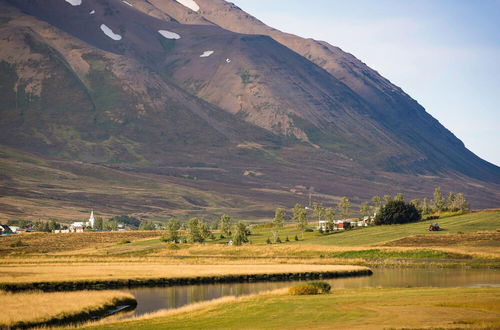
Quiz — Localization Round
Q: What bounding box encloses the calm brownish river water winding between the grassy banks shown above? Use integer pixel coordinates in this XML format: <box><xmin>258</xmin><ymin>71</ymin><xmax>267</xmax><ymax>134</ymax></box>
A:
<box><xmin>116</xmin><ymin>269</ymin><xmax>500</xmax><ymax>318</ymax></box>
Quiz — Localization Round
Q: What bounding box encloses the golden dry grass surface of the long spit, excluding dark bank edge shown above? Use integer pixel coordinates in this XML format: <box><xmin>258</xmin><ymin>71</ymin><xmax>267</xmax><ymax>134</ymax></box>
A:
<box><xmin>0</xmin><ymin>262</ymin><xmax>366</xmax><ymax>283</ymax></box>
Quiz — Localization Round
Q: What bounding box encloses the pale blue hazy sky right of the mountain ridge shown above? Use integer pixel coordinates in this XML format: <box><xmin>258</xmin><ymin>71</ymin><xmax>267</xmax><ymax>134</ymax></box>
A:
<box><xmin>229</xmin><ymin>0</ymin><xmax>500</xmax><ymax>165</ymax></box>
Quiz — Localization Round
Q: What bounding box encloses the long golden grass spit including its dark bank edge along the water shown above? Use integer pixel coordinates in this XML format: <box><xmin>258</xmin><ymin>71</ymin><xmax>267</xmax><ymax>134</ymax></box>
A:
<box><xmin>0</xmin><ymin>263</ymin><xmax>371</xmax><ymax>291</ymax></box>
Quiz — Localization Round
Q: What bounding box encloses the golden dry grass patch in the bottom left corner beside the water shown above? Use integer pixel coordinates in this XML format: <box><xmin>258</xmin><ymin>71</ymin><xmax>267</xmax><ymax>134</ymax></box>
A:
<box><xmin>0</xmin><ymin>291</ymin><xmax>134</xmax><ymax>328</ymax></box>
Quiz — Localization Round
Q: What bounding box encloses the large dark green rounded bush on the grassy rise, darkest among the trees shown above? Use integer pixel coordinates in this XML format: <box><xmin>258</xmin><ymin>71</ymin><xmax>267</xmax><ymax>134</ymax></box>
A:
<box><xmin>375</xmin><ymin>200</ymin><xmax>422</xmax><ymax>225</ymax></box>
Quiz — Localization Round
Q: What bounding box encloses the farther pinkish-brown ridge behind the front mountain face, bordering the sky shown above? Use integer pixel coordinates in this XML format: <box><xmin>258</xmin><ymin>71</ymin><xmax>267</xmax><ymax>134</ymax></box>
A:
<box><xmin>130</xmin><ymin>0</ymin><xmax>500</xmax><ymax>182</ymax></box>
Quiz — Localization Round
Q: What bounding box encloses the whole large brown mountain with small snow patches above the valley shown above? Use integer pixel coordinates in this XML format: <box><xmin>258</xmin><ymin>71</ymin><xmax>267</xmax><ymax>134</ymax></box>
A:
<box><xmin>0</xmin><ymin>0</ymin><xmax>500</xmax><ymax>222</ymax></box>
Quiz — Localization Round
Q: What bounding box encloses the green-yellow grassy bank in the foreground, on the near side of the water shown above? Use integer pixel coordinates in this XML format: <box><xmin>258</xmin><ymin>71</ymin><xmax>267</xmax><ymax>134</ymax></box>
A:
<box><xmin>90</xmin><ymin>288</ymin><xmax>500</xmax><ymax>329</ymax></box>
